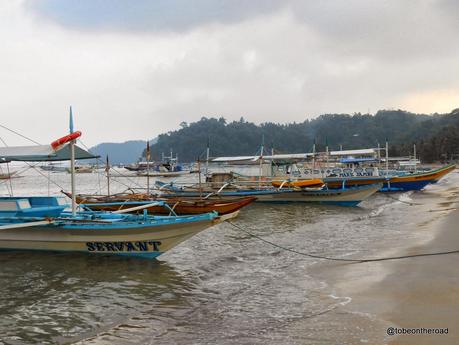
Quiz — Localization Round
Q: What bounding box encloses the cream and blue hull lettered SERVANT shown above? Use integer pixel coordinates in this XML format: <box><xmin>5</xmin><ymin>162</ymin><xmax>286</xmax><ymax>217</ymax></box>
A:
<box><xmin>0</xmin><ymin>214</ymin><xmax>221</xmax><ymax>258</ymax></box>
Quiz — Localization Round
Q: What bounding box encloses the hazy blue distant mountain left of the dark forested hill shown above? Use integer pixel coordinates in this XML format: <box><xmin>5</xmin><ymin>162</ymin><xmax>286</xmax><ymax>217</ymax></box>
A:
<box><xmin>90</xmin><ymin>138</ymin><xmax>157</xmax><ymax>164</ymax></box>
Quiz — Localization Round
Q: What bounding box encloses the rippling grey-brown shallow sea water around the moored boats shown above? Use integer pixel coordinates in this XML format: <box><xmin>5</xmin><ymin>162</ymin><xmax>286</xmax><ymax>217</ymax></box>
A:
<box><xmin>0</xmin><ymin>166</ymin><xmax>459</xmax><ymax>344</ymax></box>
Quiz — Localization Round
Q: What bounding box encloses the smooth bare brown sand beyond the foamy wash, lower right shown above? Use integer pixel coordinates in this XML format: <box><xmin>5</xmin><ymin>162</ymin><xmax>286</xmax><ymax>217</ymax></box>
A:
<box><xmin>382</xmin><ymin>206</ymin><xmax>459</xmax><ymax>344</ymax></box>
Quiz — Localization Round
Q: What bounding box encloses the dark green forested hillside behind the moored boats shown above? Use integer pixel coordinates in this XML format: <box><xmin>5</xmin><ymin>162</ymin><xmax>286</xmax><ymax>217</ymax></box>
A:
<box><xmin>148</xmin><ymin>109</ymin><xmax>459</xmax><ymax>161</ymax></box>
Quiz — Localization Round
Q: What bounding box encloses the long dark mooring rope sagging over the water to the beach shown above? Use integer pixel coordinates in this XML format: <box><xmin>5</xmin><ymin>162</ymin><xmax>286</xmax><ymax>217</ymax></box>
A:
<box><xmin>226</xmin><ymin>220</ymin><xmax>459</xmax><ymax>263</ymax></box>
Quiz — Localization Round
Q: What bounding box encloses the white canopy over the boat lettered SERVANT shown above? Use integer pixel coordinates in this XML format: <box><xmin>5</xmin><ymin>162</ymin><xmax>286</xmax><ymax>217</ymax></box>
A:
<box><xmin>0</xmin><ymin>144</ymin><xmax>99</xmax><ymax>163</ymax></box>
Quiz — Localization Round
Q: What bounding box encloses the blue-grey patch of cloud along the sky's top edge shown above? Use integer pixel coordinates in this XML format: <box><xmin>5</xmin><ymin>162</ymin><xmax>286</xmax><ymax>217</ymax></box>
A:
<box><xmin>25</xmin><ymin>0</ymin><xmax>282</xmax><ymax>32</ymax></box>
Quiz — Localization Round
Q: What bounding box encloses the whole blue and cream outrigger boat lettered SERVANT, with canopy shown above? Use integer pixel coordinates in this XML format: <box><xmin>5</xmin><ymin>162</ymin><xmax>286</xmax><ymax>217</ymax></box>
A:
<box><xmin>0</xmin><ymin>114</ymin><xmax>233</xmax><ymax>258</ymax></box>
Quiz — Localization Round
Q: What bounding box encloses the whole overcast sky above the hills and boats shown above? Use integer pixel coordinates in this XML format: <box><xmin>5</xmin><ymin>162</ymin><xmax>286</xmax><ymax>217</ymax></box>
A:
<box><xmin>0</xmin><ymin>0</ymin><xmax>459</xmax><ymax>145</ymax></box>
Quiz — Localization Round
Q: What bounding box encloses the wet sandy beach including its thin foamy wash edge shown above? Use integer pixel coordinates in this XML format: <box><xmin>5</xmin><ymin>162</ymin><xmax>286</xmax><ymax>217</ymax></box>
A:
<box><xmin>314</xmin><ymin>176</ymin><xmax>459</xmax><ymax>345</ymax></box>
